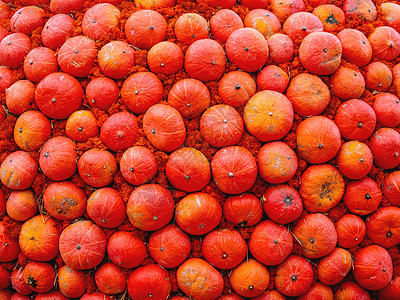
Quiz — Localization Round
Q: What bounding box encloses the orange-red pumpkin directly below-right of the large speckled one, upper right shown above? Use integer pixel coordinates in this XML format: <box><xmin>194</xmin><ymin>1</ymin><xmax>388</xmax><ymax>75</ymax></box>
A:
<box><xmin>330</xmin><ymin>66</ymin><xmax>365</xmax><ymax>100</ymax></box>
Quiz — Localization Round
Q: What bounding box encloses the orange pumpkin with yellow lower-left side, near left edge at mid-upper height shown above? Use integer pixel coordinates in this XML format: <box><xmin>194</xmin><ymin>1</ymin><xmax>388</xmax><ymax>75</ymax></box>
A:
<box><xmin>14</xmin><ymin>110</ymin><xmax>51</xmax><ymax>151</ymax></box>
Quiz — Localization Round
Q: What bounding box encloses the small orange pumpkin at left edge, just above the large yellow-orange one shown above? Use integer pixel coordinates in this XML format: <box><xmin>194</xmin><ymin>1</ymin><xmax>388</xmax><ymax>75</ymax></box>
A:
<box><xmin>6</xmin><ymin>190</ymin><xmax>38</xmax><ymax>222</ymax></box>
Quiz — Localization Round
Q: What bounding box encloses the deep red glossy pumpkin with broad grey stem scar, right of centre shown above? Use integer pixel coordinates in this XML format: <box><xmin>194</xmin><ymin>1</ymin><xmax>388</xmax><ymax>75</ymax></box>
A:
<box><xmin>261</xmin><ymin>185</ymin><xmax>303</xmax><ymax>224</ymax></box>
